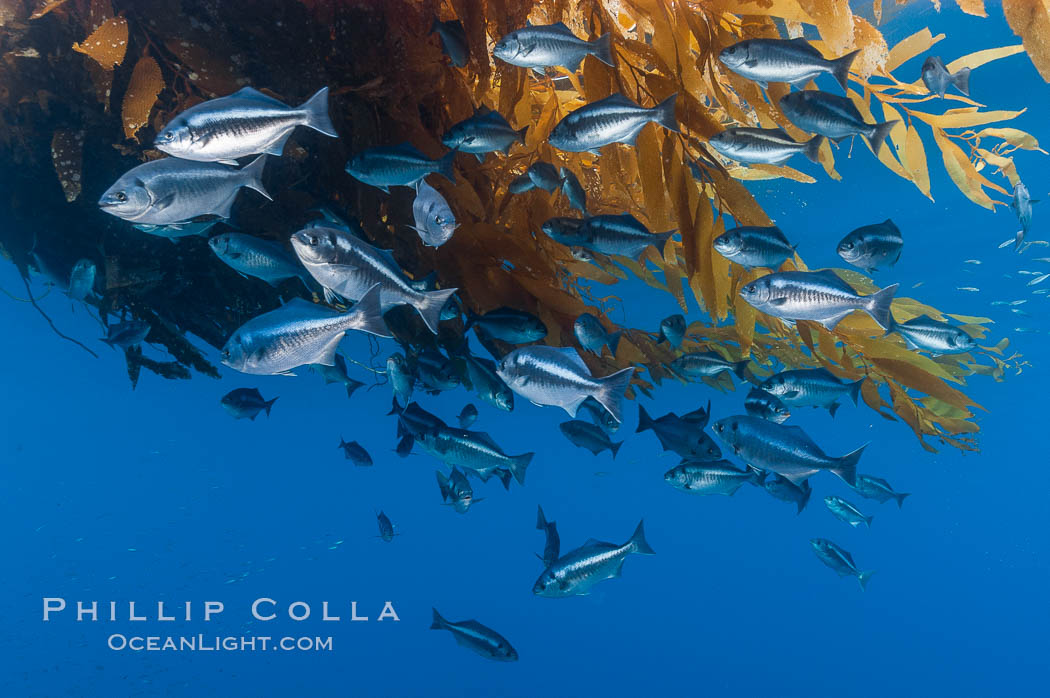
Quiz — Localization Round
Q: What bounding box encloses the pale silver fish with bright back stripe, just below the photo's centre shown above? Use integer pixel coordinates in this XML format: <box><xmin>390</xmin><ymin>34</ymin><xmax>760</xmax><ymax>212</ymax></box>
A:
<box><xmin>496</xmin><ymin>345</ymin><xmax>634</xmax><ymax>422</ymax></box>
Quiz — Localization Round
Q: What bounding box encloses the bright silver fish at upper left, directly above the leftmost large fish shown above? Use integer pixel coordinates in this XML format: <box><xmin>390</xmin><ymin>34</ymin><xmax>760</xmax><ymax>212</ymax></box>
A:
<box><xmin>153</xmin><ymin>87</ymin><xmax>331</xmax><ymax>165</ymax></box>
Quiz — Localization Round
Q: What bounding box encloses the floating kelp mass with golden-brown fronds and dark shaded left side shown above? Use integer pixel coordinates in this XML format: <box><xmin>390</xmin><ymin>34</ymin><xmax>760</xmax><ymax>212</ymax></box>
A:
<box><xmin>0</xmin><ymin>0</ymin><xmax>1048</xmax><ymax>449</ymax></box>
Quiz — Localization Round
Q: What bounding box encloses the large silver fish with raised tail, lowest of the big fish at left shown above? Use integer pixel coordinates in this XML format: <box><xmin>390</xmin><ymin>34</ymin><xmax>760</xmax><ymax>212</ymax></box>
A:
<box><xmin>222</xmin><ymin>284</ymin><xmax>390</xmax><ymax>376</ymax></box>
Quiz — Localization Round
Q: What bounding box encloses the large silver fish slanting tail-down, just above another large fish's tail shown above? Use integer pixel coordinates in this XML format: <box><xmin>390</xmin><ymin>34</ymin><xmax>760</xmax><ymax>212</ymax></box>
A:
<box><xmin>292</xmin><ymin>227</ymin><xmax>458</xmax><ymax>334</ymax></box>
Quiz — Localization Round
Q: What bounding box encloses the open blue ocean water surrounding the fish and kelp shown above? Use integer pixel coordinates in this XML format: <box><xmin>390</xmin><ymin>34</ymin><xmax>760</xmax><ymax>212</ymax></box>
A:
<box><xmin>0</xmin><ymin>3</ymin><xmax>1050</xmax><ymax>697</ymax></box>
